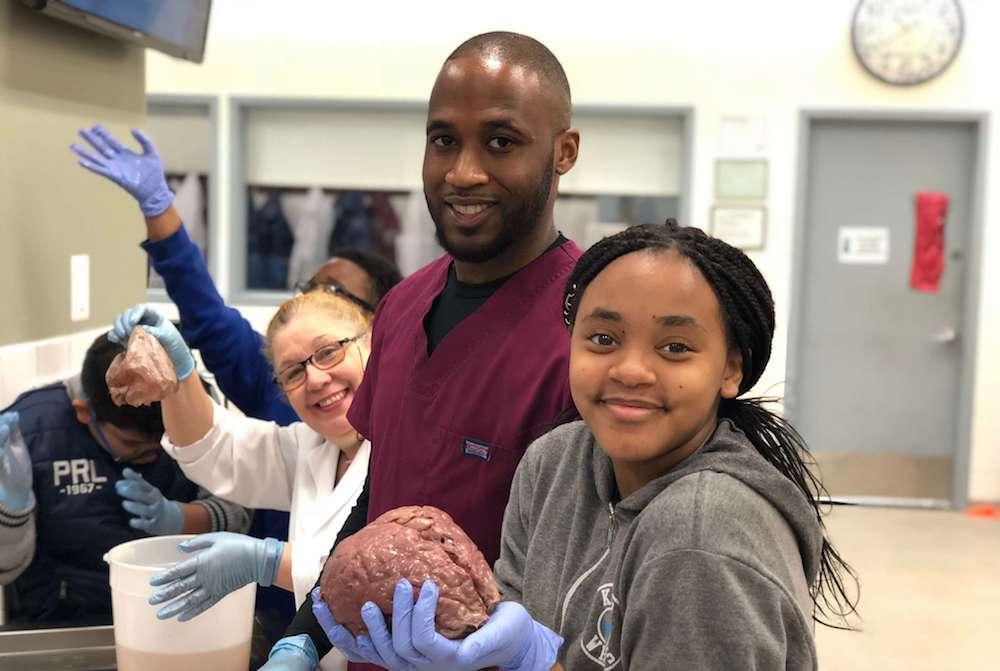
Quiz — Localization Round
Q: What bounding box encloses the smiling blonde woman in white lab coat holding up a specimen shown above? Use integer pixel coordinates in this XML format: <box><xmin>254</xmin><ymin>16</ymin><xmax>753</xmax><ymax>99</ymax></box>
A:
<box><xmin>111</xmin><ymin>291</ymin><xmax>371</xmax><ymax>670</ymax></box>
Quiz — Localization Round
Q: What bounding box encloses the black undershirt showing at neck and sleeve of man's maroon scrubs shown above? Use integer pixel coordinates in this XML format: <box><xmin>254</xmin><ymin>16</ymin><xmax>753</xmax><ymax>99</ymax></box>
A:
<box><xmin>285</xmin><ymin>233</ymin><xmax>566</xmax><ymax>659</ymax></box>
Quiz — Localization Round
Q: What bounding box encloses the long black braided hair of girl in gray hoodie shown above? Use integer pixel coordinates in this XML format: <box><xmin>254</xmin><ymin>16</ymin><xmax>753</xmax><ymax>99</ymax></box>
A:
<box><xmin>563</xmin><ymin>219</ymin><xmax>857</xmax><ymax>628</ymax></box>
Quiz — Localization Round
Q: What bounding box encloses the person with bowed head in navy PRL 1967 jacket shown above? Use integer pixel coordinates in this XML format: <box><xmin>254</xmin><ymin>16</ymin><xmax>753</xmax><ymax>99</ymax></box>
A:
<box><xmin>0</xmin><ymin>335</ymin><xmax>250</xmax><ymax>624</ymax></box>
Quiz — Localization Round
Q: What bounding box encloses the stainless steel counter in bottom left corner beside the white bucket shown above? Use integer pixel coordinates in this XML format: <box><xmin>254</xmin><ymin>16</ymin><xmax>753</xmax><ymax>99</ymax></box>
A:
<box><xmin>0</xmin><ymin>626</ymin><xmax>117</xmax><ymax>671</ymax></box>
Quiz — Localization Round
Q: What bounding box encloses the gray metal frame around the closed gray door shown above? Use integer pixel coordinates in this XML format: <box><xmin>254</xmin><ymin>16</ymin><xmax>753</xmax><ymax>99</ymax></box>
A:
<box><xmin>785</xmin><ymin>109</ymin><xmax>990</xmax><ymax>509</ymax></box>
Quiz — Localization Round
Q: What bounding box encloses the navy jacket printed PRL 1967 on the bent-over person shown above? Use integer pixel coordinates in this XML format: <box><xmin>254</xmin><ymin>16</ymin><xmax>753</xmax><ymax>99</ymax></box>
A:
<box><xmin>8</xmin><ymin>383</ymin><xmax>198</xmax><ymax>622</ymax></box>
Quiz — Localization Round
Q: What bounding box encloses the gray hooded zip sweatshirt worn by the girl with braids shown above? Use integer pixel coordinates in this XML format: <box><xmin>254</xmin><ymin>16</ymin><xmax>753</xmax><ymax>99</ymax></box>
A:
<box><xmin>495</xmin><ymin>420</ymin><xmax>823</xmax><ymax>671</ymax></box>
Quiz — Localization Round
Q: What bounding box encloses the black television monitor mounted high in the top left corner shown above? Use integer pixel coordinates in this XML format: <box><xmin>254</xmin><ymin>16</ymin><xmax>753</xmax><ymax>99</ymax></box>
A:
<box><xmin>22</xmin><ymin>0</ymin><xmax>212</xmax><ymax>63</ymax></box>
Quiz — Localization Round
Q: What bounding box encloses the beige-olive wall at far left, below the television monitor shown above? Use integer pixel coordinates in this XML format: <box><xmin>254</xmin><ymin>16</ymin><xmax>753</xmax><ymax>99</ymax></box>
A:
<box><xmin>0</xmin><ymin>1</ymin><xmax>146</xmax><ymax>345</ymax></box>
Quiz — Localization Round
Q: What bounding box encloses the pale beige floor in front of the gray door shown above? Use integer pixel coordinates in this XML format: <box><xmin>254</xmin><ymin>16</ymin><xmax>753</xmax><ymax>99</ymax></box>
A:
<box><xmin>816</xmin><ymin>506</ymin><xmax>1000</xmax><ymax>671</ymax></box>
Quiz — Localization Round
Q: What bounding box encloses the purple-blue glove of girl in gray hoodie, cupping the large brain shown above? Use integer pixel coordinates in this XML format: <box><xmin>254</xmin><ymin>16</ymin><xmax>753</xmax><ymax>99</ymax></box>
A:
<box><xmin>361</xmin><ymin>580</ymin><xmax>563</xmax><ymax>671</ymax></box>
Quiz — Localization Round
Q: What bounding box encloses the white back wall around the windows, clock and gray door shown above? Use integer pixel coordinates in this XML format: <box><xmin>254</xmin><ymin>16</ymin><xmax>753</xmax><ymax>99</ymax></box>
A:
<box><xmin>147</xmin><ymin>0</ymin><xmax>1000</xmax><ymax>499</ymax></box>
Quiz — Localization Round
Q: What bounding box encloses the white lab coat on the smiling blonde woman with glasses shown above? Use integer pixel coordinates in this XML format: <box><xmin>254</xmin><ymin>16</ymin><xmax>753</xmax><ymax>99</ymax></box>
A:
<box><xmin>163</xmin><ymin>404</ymin><xmax>371</xmax><ymax>671</ymax></box>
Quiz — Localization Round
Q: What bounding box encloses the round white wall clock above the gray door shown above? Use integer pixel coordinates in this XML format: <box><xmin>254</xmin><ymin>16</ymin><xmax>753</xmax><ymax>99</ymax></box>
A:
<box><xmin>851</xmin><ymin>0</ymin><xmax>963</xmax><ymax>86</ymax></box>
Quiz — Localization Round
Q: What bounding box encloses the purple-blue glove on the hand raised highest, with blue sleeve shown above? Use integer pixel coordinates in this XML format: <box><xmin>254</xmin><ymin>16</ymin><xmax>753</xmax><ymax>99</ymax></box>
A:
<box><xmin>69</xmin><ymin>124</ymin><xmax>174</xmax><ymax>217</ymax></box>
